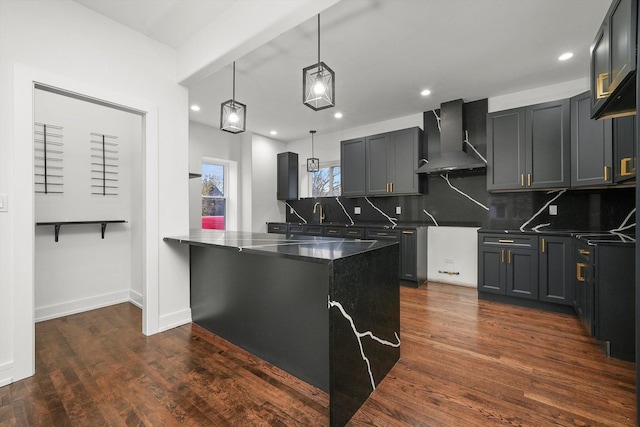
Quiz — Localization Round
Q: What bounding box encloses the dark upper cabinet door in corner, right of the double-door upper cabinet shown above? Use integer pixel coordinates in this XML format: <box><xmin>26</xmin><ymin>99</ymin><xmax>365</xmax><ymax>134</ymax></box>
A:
<box><xmin>571</xmin><ymin>92</ymin><xmax>613</xmax><ymax>187</ymax></box>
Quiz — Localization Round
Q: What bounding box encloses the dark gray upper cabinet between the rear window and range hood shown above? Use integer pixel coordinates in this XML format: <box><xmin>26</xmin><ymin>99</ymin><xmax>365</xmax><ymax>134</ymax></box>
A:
<box><xmin>340</xmin><ymin>127</ymin><xmax>427</xmax><ymax>196</ymax></box>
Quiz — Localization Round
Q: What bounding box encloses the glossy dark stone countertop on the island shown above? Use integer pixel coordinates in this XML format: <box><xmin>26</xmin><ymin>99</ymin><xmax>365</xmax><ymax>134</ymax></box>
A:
<box><xmin>164</xmin><ymin>229</ymin><xmax>398</xmax><ymax>263</ymax></box>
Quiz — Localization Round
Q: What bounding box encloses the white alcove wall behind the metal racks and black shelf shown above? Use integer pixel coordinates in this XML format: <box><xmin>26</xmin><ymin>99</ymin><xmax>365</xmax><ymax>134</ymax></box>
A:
<box><xmin>34</xmin><ymin>90</ymin><xmax>143</xmax><ymax>322</ymax></box>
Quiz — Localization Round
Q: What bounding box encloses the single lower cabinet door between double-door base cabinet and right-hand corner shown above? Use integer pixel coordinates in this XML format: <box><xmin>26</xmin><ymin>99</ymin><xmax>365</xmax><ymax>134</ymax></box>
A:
<box><xmin>538</xmin><ymin>236</ymin><xmax>574</xmax><ymax>305</ymax></box>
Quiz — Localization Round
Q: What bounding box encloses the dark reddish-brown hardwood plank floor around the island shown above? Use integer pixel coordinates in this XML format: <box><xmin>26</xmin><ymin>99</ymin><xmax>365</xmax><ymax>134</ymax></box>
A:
<box><xmin>0</xmin><ymin>283</ymin><xmax>636</xmax><ymax>426</ymax></box>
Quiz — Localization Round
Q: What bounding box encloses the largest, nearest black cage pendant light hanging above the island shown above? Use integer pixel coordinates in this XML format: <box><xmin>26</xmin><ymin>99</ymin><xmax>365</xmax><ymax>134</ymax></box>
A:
<box><xmin>302</xmin><ymin>14</ymin><xmax>336</xmax><ymax>111</ymax></box>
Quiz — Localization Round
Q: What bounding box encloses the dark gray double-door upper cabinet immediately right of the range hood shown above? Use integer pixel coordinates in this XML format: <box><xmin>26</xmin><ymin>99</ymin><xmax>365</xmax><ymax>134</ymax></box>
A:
<box><xmin>487</xmin><ymin>99</ymin><xmax>571</xmax><ymax>191</ymax></box>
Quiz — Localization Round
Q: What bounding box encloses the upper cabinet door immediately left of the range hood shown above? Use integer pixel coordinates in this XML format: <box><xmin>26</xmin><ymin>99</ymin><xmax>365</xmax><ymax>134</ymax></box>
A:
<box><xmin>389</xmin><ymin>128</ymin><xmax>421</xmax><ymax>194</ymax></box>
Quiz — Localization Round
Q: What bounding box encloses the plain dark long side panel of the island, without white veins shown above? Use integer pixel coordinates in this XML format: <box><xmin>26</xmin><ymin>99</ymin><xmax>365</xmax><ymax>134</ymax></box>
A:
<box><xmin>190</xmin><ymin>246</ymin><xmax>329</xmax><ymax>392</ymax></box>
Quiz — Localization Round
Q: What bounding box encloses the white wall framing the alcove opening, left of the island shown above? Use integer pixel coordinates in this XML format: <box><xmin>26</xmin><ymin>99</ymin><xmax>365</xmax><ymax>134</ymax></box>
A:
<box><xmin>0</xmin><ymin>0</ymin><xmax>190</xmax><ymax>385</ymax></box>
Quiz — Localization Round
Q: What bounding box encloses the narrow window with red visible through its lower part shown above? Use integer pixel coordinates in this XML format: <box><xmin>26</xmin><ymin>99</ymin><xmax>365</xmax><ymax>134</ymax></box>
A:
<box><xmin>202</xmin><ymin>163</ymin><xmax>227</xmax><ymax>230</ymax></box>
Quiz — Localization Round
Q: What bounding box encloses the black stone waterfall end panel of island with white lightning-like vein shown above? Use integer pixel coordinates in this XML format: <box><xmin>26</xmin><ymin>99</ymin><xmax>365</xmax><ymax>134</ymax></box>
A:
<box><xmin>329</xmin><ymin>245</ymin><xmax>400</xmax><ymax>426</ymax></box>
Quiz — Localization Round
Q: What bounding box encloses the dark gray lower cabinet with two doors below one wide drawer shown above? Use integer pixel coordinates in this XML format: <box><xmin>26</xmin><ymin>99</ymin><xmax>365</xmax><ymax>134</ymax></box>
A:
<box><xmin>478</xmin><ymin>232</ymin><xmax>538</xmax><ymax>300</ymax></box>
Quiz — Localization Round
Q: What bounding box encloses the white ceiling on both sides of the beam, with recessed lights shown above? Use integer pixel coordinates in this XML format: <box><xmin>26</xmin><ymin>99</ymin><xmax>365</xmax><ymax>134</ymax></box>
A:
<box><xmin>76</xmin><ymin>0</ymin><xmax>610</xmax><ymax>141</ymax></box>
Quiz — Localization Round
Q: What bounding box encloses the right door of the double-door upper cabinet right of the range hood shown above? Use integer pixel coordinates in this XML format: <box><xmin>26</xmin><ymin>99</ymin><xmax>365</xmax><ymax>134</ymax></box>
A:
<box><xmin>525</xmin><ymin>99</ymin><xmax>571</xmax><ymax>188</ymax></box>
